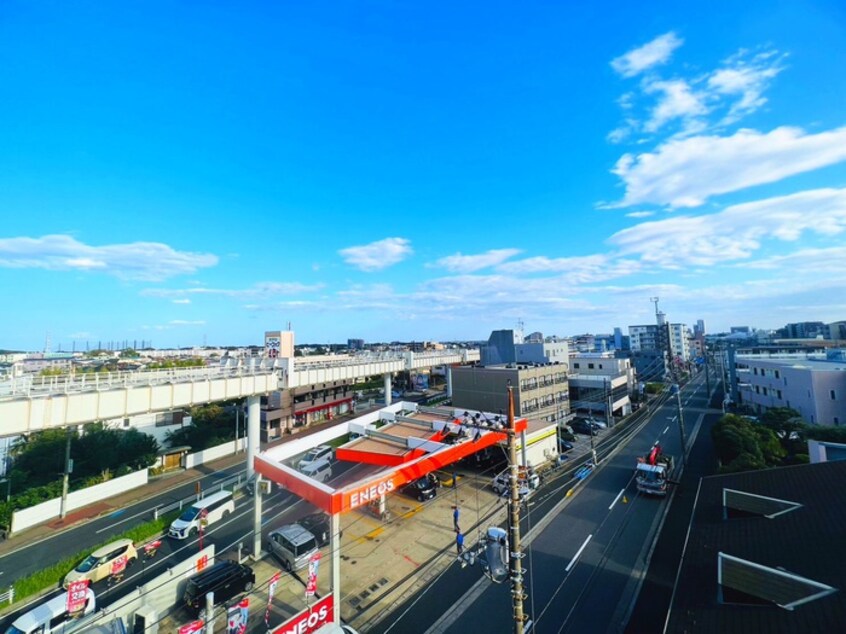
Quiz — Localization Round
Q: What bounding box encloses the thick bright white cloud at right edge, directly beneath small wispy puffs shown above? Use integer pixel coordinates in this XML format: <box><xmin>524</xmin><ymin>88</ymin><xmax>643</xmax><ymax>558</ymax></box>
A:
<box><xmin>609</xmin><ymin>127</ymin><xmax>846</xmax><ymax>207</ymax></box>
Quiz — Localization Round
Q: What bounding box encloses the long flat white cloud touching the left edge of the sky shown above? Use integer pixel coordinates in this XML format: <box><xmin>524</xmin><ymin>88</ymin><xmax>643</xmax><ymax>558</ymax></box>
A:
<box><xmin>0</xmin><ymin>235</ymin><xmax>218</xmax><ymax>281</ymax></box>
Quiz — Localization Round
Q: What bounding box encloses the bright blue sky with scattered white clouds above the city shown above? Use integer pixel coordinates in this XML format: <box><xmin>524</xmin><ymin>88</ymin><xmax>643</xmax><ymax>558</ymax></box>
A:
<box><xmin>0</xmin><ymin>1</ymin><xmax>846</xmax><ymax>350</ymax></box>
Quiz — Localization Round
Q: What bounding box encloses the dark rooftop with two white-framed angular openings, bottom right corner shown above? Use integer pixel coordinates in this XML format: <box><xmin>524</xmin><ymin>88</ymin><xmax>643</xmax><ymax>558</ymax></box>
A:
<box><xmin>666</xmin><ymin>462</ymin><xmax>846</xmax><ymax>634</ymax></box>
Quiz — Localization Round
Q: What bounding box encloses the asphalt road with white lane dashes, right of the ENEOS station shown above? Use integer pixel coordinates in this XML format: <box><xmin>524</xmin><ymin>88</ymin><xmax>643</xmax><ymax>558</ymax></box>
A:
<box><xmin>372</xmin><ymin>370</ymin><xmax>716</xmax><ymax>634</ymax></box>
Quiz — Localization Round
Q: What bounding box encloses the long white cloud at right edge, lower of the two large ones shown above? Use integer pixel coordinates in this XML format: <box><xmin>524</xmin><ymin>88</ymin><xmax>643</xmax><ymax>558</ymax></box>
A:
<box><xmin>608</xmin><ymin>188</ymin><xmax>846</xmax><ymax>269</ymax></box>
